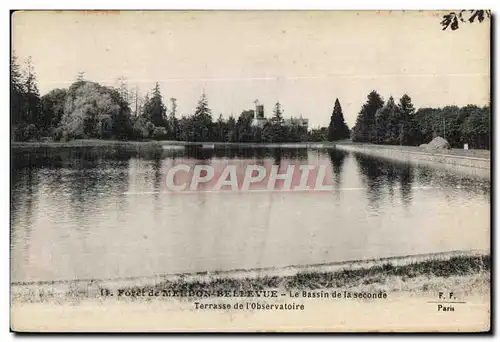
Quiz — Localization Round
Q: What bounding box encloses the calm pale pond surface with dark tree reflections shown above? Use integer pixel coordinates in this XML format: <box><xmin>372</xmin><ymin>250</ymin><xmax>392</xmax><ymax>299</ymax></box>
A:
<box><xmin>11</xmin><ymin>148</ymin><xmax>490</xmax><ymax>281</ymax></box>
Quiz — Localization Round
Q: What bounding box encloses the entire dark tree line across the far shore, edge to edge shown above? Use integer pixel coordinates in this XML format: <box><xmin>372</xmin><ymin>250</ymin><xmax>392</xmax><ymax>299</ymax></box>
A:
<box><xmin>11</xmin><ymin>56</ymin><xmax>490</xmax><ymax>148</ymax></box>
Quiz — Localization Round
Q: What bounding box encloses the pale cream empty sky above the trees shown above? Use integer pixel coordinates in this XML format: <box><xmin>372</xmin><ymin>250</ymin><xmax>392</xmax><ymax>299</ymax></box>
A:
<box><xmin>12</xmin><ymin>11</ymin><xmax>490</xmax><ymax>127</ymax></box>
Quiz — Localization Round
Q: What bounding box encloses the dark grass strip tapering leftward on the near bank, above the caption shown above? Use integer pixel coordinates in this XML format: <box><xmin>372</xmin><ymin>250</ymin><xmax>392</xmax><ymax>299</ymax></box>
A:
<box><xmin>102</xmin><ymin>255</ymin><xmax>490</xmax><ymax>293</ymax></box>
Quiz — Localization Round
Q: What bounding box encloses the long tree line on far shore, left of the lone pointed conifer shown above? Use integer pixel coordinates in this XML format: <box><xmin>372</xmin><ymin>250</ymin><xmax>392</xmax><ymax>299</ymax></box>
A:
<box><xmin>11</xmin><ymin>56</ymin><xmax>336</xmax><ymax>143</ymax></box>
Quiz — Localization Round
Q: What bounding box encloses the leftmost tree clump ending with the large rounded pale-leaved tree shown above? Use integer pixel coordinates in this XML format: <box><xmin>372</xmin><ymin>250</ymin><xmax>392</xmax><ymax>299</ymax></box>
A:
<box><xmin>10</xmin><ymin>56</ymin><xmax>132</xmax><ymax>141</ymax></box>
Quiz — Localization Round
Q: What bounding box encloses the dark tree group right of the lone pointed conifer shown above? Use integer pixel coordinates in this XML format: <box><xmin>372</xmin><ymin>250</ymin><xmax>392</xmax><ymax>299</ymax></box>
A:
<box><xmin>352</xmin><ymin>91</ymin><xmax>490</xmax><ymax>149</ymax></box>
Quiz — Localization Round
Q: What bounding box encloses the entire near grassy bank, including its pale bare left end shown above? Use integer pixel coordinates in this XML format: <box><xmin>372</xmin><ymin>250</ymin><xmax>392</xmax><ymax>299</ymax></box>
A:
<box><xmin>12</xmin><ymin>254</ymin><xmax>491</xmax><ymax>302</ymax></box>
